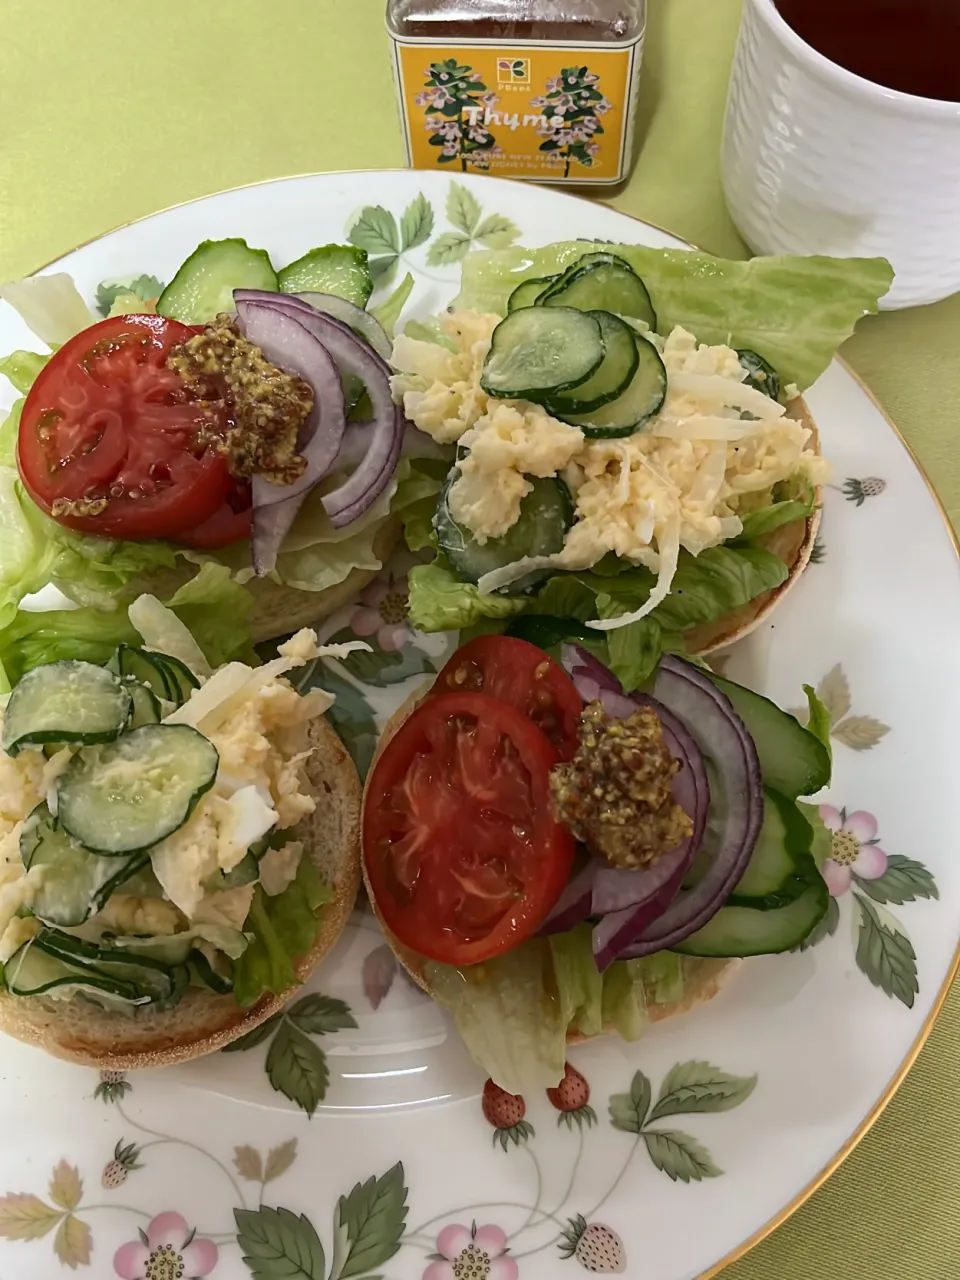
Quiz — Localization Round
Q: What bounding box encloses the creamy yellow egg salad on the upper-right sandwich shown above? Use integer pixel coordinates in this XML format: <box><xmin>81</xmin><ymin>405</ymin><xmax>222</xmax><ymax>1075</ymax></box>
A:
<box><xmin>393</xmin><ymin>311</ymin><xmax>829</xmax><ymax>626</ymax></box>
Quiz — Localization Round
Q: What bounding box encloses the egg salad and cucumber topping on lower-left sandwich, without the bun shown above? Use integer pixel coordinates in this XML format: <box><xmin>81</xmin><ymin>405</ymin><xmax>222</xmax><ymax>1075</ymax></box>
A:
<box><xmin>0</xmin><ymin>596</ymin><xmax>367</xmax><ymax>1007</ymax></box>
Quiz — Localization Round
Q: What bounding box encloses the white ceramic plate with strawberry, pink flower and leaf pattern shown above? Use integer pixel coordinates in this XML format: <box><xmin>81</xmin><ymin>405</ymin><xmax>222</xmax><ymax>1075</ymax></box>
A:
<box><xmin>0</xmin><ymin>173</ymin><xmax>960</xmax><ymax>1280</ymax></box>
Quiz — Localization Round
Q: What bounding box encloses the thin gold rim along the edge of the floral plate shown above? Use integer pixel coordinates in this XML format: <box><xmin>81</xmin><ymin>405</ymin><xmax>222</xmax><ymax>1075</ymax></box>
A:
<box><xmin>15</xmin><ymin>166</ymin><xmax>960</xmax><ymax>1280</ymax></box>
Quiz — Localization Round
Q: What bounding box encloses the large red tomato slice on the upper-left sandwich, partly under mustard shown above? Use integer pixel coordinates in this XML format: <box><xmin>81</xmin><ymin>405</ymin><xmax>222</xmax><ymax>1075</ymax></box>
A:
<box><xmin>17</xmin><ymin>315</ymin><xmax>248</xmax><ymax>545</ymax></box>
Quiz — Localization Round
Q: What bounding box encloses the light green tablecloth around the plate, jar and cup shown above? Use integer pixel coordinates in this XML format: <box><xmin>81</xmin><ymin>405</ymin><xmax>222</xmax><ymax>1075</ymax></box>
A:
<box><xmin>0</xmin><ymin>0</ymin><xmax>960</xmax><ymax>1280</ymax></box>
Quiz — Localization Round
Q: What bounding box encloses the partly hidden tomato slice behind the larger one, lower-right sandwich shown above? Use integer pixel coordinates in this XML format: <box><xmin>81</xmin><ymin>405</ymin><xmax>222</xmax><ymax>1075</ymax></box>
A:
<box><xmin>433</xmin><ymin>636</ymin><xmax>584</xmax><ymax>760</ymax></box>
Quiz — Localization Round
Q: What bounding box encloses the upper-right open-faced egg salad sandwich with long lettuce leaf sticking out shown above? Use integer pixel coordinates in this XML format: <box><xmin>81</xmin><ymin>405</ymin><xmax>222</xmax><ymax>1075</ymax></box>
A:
<box><xmin>393</xmin><ymin>242</ymin><xmax>890</xmax><ymax>689</ymax></box>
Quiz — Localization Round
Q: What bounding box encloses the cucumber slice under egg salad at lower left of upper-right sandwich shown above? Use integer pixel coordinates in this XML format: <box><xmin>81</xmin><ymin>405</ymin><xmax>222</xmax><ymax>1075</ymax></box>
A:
<box><xmin>434</xmin><ymin>467</ymin><xmax>573</xmax><ymax>595</ymax></box>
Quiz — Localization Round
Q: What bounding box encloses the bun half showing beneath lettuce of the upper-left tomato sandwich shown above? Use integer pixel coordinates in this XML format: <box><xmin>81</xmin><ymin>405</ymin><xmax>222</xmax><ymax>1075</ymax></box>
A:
<box><xmin>137</xmin><ymin>518</ymin><xmax>401</xmax><ymax>644</ymax></box>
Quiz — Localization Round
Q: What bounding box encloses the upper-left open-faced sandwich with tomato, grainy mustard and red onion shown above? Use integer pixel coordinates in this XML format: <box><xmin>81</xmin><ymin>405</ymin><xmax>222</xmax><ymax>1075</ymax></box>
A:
<box><xmin>0</xmin><ymin>239</ymin><xmax>436</xmax><ymax>648</ymax></box>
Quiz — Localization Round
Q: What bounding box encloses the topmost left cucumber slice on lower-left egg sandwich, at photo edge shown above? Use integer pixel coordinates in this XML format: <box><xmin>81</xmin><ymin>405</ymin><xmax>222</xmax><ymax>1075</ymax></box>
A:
<box><xmin>0</xmin><ymin>659</ymin><xmax>132</xmax><ymax>755</ymax></box>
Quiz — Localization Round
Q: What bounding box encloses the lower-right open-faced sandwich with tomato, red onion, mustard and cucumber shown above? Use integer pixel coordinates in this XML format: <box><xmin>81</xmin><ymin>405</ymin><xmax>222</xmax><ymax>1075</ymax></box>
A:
<box><xmin>364</xmin><ymin>636</ymin><xmax>831</xmax><ymax>1093</ymax></box>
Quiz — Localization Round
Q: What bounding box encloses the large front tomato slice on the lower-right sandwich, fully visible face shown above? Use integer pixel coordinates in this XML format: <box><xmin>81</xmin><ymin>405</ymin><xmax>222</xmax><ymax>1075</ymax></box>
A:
<box><xmin>364</xmin><ymin>692</ymin><xmax>575</xmax><ymax>965</ymax></box>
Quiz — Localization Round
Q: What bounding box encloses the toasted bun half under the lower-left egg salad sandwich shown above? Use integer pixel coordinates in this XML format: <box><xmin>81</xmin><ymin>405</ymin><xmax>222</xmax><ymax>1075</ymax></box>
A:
<box><xmin>0</xmin><ymin>717</ymin><xmax>360</xmax><ymax>1071</ymax></box>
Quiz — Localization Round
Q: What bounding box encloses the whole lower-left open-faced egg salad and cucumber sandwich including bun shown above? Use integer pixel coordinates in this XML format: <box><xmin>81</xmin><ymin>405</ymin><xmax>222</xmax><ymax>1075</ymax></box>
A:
<box><xmin>0</xmin><ymin>595</ymin><xmax>360</xmax><ymax>1069</ymax></box>
